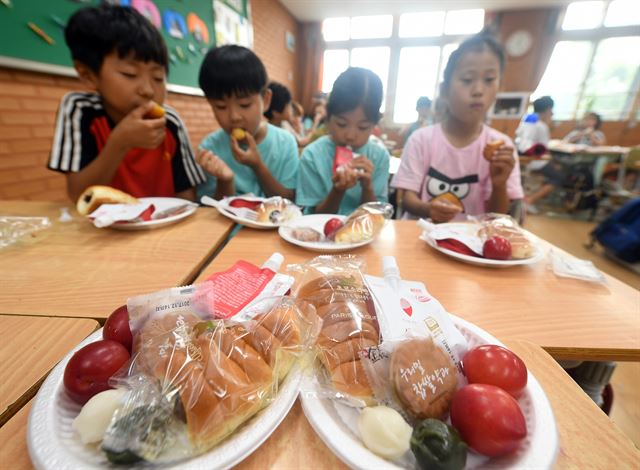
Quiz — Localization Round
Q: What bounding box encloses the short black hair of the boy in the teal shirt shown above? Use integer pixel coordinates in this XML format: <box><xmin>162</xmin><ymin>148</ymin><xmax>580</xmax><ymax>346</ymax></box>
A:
<box><xmin>199</xmin><ymin>45</ymin><xmax>267</xmax><ymax>100</ymax></box>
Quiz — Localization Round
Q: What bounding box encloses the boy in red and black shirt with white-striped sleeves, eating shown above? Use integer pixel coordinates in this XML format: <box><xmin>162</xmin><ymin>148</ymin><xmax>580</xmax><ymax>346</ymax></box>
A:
<box><xmin>49</xmin><ymin>6</ymin><xmax>205</xmax><ymax>201</ymax></box>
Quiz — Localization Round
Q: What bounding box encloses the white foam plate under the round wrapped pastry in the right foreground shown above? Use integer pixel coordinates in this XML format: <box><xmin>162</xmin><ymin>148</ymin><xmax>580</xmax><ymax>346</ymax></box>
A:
<box><xmin>300</xmin><ymin>315</ymin><xmax>560</xmax><ymax>470</ymax></box>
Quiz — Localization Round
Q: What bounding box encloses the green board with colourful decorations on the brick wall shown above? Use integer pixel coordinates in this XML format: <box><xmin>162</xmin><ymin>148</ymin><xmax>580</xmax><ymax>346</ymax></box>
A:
<box><xmin>0</xmin><ymin>0</ymin><xmax>249</xmax><ymax>92</ymax></box>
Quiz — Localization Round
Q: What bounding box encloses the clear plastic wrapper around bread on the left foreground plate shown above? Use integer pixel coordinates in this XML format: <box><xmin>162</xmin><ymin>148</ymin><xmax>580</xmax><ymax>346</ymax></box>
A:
<box><xmin>102</xmin><ymin>282</ymin><xmax>320</xmax><ymax>463</ymax></box>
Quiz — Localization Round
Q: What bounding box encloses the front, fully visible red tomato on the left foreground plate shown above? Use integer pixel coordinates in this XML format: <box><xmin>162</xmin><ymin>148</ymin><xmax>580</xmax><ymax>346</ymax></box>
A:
<box><xmin>64</xmin><ymin>339</ymin><xmax>129</xmax><ymax>405</ymax></box>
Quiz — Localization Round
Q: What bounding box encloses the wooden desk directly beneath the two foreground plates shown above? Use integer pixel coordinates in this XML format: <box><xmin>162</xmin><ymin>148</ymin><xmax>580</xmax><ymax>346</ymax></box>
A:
<box><xmin>0</xmin><ymin>340</ymin><xmax>640</xmax><ymax>470</ymax></box>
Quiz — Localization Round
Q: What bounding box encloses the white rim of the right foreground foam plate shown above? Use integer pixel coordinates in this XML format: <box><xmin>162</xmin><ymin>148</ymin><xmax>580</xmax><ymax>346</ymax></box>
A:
<box><xmin>300</xmin><ymin>314</ymin><xmax>560</xmax><ymax>470</ymax></box>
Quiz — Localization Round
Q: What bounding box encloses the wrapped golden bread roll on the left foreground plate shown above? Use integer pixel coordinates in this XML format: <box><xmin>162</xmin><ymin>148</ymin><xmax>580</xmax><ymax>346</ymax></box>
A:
<box><xmin>134</xmin><ymin>303</ymin><xmax>302</xmax><ymax>451</ymax></box>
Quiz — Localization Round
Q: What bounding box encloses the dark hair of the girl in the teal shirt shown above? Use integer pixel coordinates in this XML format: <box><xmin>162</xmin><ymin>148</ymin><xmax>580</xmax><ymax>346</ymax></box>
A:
<box><xmin>327</xmin><ymin>67</ymin><xmax>382</xmax><ymax>123</ymax></box>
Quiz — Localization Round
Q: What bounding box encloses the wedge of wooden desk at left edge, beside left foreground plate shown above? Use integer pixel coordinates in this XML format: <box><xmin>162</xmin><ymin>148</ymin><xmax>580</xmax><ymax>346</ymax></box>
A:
<box><xmin>0</xmin><ymin>315</ymin><xmax>99</xmax><ymax>424</ymax></box>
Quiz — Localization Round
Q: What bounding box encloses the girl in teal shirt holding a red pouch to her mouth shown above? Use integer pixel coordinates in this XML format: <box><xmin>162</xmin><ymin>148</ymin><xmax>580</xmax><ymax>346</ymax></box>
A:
<box><xmin>296</xmin><ymin>67</ymin><xmax>389</xmax><ymax>215</ymax></box>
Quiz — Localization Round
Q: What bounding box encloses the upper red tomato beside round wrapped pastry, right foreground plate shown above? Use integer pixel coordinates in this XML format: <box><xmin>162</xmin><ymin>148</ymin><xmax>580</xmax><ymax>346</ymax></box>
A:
<box><xmin>462</xmin><ymin>344</ymin><xmax>527</xmax><ymax>398</ymax></box>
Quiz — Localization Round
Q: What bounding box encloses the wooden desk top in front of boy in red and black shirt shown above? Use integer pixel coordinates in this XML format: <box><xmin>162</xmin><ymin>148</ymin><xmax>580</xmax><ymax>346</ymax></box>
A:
<box><xmin>0</xmin><ymin>201</ymin><xmax>234</xmax><ymax>318</ymax></box>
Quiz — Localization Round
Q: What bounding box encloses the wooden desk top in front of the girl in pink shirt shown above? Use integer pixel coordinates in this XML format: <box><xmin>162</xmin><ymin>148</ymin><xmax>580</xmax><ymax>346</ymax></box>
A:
<box><xmin>199</xmin><ymin>221</ymin><xmax>640</xmax><ymax>361</ymax></box>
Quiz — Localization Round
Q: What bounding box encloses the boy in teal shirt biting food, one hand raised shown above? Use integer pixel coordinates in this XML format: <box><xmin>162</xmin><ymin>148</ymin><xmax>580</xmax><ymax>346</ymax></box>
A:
<box><xmin>197</xmin><ymin>45</ymin><xmax>298</xmax><ymax>200</ymax></box>
